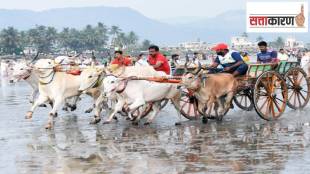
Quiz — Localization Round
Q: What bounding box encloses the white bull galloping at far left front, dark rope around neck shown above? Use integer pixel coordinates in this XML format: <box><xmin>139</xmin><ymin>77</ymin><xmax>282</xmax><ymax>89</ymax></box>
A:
<box><xmin>26</xmin><ymin>59</ymin><xmax>80</xmax><ymax>129</ymax></box>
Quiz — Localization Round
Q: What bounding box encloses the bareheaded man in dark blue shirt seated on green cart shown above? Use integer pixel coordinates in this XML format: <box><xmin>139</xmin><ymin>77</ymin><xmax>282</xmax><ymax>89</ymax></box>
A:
<box><xmin>257</xmin><ymin>41</ymin><xmax>278</xmax><ymax>63</ymax></box>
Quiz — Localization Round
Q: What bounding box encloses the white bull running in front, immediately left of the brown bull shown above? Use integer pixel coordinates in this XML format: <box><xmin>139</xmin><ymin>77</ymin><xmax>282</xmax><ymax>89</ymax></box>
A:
<box><xmin>103</xmin><ymin>76</ymin><xmax>181</xmax><ymax>124</ymax></box>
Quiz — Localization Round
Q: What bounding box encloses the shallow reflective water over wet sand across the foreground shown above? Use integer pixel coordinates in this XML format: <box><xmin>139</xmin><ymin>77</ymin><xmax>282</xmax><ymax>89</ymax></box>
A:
<box><xmin>0</xmin><ymin>83</ymin><xmax>310</xmax><ymax>174</ymax></box>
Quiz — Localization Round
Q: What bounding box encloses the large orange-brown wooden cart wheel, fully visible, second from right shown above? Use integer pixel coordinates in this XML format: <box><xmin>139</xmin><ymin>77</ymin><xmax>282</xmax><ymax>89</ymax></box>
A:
<box><xmin>253</xmin><ymin>71</ymin><xmax>287</xmax><ymax>121</ymax></box>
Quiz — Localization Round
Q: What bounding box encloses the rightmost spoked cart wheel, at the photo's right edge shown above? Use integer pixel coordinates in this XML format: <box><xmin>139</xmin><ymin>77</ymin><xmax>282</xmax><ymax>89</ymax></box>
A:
<box><xmin>285</xmin><ymin>68</ymin><xmax>310</xmax><ymax>109</ymax></box>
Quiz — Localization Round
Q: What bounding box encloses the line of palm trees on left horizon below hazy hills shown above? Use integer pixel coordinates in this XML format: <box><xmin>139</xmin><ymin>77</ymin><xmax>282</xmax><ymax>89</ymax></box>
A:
<box><xmin>0</xmin><ymin>22</ymin><xmax>151</xmax><ymax>55</ymax></box>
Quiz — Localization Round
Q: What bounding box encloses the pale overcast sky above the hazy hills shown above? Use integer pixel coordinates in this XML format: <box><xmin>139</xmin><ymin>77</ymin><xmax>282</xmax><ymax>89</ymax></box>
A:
<box><xmin>0</xmin><ymin>0</ymin><xmax>309</xmax><ymax>19</ymax></box>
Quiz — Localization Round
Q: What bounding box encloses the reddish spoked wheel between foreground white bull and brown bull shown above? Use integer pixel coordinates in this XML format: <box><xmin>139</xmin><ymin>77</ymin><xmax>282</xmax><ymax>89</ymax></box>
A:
<box><xmin>179</xmin><ymin>89</ymin><xmax>200</xmax><ymax>120</ymax></box>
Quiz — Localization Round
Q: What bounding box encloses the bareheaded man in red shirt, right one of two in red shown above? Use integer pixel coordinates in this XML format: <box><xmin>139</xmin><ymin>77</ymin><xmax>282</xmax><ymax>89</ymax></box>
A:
<box><xmin>148</xmin><ymin>45</ymin><xmax>170</xmax><ymax>75</ymax></box>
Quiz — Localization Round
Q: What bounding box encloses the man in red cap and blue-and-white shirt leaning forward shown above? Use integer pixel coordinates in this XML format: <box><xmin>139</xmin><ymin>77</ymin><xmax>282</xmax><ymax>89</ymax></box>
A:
<box><xmin>210</xmin><ymin>43</ymin><xmax>248</xmax><ymax>76</ymax></box>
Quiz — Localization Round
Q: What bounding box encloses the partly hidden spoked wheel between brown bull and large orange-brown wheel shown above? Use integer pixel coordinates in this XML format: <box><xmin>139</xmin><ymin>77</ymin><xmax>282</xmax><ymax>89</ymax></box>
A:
<box><xmin>233</xmin><ymin>89</ymin><xmax>254</xmax><ymax>111</ymax></box>
